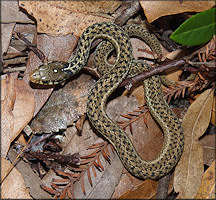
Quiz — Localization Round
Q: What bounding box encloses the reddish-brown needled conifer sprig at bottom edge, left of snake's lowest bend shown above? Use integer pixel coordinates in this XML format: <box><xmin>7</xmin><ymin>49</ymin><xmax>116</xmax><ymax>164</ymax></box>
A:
<box><xmin>41</xmin><ymin>142</ymin><xmax>115</xmax><ymax>199</ymax></box>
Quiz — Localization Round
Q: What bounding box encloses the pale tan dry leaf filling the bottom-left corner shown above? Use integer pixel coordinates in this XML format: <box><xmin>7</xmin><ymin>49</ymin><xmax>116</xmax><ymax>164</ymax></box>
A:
<box><xmin>1</xmin><ymin>157</ymin><xmax>32</xmax><ymax>199</ymax></box>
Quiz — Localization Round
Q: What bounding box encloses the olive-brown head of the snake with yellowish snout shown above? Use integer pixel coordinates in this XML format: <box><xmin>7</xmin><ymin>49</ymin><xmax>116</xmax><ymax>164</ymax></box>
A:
<box><xmin>29</xmin><ymin>62</ymin><xmax>69</xmax><ymax>85</ymax></box>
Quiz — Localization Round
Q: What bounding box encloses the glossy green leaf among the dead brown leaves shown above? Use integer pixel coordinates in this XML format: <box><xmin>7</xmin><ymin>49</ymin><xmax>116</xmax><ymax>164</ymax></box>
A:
<box><xmin>170</xmin><ymin>8</ymin><xmax>216</xmax><ymax>45</ymax></box>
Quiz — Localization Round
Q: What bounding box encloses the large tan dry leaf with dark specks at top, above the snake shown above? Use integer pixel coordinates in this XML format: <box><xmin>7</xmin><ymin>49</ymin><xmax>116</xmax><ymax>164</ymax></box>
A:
<box><xmin>19</xmin><ymin>1</ymin><xmax>121</xmax><ymax>36</ymax></box>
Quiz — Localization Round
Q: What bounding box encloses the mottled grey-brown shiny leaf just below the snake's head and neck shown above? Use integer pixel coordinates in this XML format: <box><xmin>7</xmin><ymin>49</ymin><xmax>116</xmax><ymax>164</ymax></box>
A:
<box><xmin>30</xmin><ymin>74</ymin><xmax>94</xmax><ymax>133</ymax></box>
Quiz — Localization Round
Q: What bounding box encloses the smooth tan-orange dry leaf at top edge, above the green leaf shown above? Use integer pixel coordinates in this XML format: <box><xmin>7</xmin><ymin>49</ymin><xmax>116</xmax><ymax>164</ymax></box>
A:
<box><xmin>140</xmin><ymin>1</ymin><xmax>215</xmax><ymax>23</ymax></box>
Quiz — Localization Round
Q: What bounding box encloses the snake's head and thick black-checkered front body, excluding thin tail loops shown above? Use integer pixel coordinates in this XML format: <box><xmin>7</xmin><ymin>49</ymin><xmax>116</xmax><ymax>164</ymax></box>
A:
<box><xmin>29</xmin><ymin>22</ymin><xmax>184</xmax><ymax>179</ymax></box>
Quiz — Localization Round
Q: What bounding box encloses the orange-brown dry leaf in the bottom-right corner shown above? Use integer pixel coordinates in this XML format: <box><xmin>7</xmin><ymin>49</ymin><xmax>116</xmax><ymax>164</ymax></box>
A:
<box><xmin>195</xmin><ymin>161</ymin><xmax>215</xmax><ymax>199</ymax></box>
